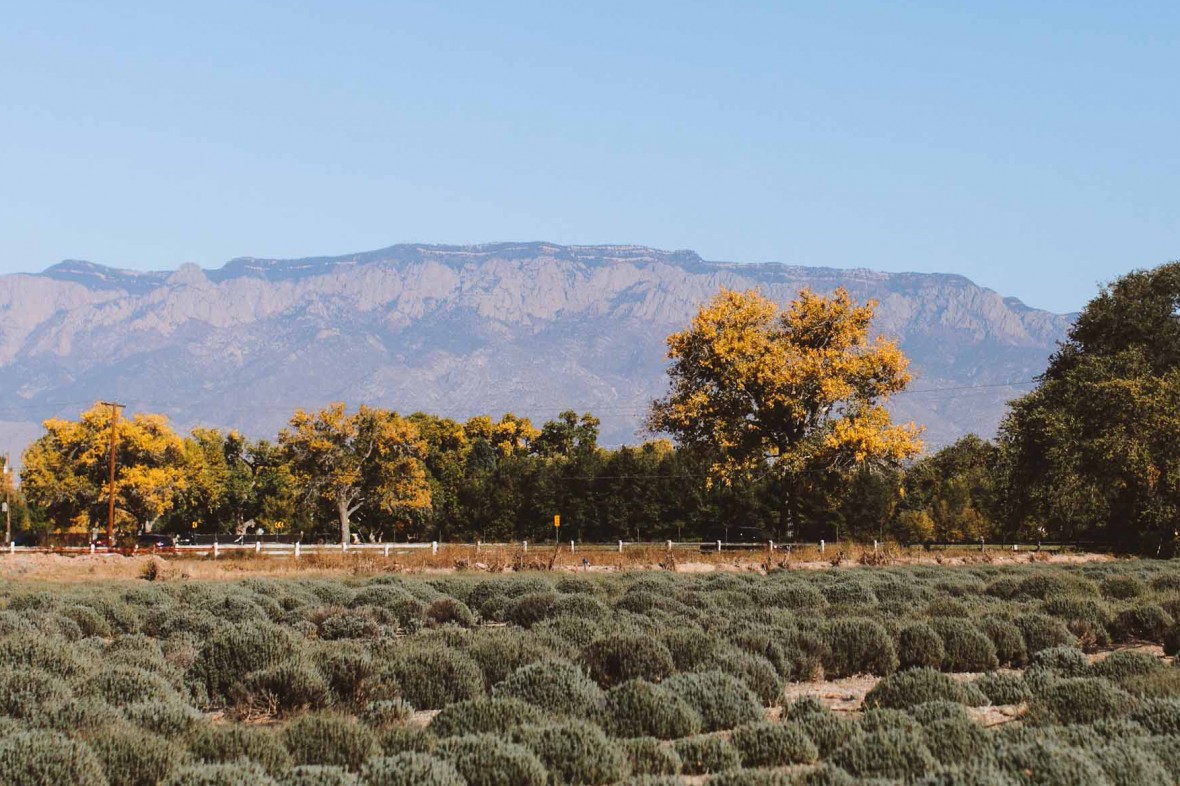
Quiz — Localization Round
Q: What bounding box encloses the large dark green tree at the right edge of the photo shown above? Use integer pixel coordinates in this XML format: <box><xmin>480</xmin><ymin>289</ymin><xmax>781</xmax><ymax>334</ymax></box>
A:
<box><xmin>1001</xmin><ymin>262</ymin><xmax>1180</xmax><ymax>555</ymax></box>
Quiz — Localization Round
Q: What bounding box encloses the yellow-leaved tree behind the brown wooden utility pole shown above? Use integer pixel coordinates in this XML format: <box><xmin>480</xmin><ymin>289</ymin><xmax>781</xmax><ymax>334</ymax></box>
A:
<box><xmin>20</xmin><ymin>405</ymin><xmax>189</xmax><ymax>531</ymax></box>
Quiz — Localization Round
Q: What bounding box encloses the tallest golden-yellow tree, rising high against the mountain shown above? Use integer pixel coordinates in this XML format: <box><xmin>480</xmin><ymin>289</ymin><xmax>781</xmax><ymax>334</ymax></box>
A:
<box><xmin>648</xmin><ymin>288</ymin><xmax>922</xmax><ymax>535</ymax></box>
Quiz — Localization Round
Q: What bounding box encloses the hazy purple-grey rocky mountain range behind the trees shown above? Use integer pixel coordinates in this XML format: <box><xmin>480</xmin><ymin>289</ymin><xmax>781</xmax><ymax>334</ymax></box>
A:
<box><xmin>0</xmin><ymin>243</ymin><xmax>1070</xmax><ymax>452</ymax></box>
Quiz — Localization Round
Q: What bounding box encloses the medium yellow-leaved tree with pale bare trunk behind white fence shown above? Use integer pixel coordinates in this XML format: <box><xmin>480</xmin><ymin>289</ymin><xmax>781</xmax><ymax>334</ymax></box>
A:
<box><xmin>278</xmin><ymin>404</ymin><xmax>431</xmax><ymax>543</ymax></box>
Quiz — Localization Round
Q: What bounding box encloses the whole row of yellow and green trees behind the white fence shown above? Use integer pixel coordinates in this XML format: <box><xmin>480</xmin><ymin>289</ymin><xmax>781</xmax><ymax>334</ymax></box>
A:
<box><xmin>14</xmin><ymin>263</ymin><xmax>1180</xmax><ymax>555</ymax></box>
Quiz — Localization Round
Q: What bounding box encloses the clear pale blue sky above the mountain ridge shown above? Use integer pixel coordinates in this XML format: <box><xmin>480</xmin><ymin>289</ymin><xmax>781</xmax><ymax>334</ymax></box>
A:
<box><xmin>0</xmin><ymin>0</ymin><xmax>1180</xmax><ymax>310</ymax></box>
